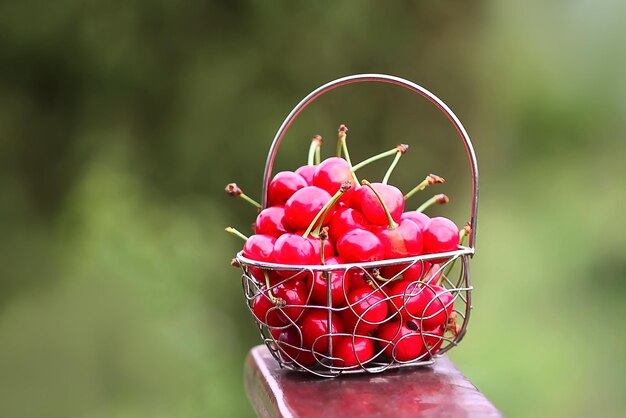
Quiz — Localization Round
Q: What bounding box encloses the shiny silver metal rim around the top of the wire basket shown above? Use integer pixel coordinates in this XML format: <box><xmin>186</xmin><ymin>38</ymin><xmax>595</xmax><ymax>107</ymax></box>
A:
<box><xmin>236</xmin><ymin>245</ymin><xmax>475</xmax><ymax>271</ymax></box>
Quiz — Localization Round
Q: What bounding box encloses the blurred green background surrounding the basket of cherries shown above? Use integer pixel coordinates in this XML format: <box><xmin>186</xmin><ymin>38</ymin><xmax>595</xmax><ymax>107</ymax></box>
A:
<box><xmin>0</xmin><ymin>0</ymin><xmax>626</xmax><ymax>418</ymax></box>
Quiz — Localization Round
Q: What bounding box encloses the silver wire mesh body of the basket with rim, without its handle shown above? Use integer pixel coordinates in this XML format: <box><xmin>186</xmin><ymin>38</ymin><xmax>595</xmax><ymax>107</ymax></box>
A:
<box><xmin>237</xmin><ymin>251</ymin><xmax>473</xmax><ymax>377</ymax></box>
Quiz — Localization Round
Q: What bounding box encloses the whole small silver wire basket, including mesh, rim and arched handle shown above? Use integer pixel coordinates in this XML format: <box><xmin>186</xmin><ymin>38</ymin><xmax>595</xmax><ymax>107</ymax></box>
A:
<box><xmin>236</xmin><ymin>74</ymin><xmax>478</xmax><ymax>377</ymax></box>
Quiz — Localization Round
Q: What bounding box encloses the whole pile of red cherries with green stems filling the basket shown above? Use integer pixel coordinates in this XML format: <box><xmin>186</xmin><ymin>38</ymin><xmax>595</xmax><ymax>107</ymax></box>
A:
<box><xmin>226</xmin><ymin>125</ymin><xmax>469</xmax><ymax>368</ymax></box>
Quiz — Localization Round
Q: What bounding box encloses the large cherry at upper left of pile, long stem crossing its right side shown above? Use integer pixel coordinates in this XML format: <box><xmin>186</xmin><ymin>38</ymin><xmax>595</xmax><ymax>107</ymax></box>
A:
<box><xmin>284</xmin><ymin>186</ymin><xmax>334</xmax><ymax>230</ymax></box>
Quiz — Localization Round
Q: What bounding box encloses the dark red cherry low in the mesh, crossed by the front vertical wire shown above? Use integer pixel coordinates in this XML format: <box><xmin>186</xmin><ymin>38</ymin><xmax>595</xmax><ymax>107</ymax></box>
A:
<box><xmin>300</xmin><ymin>309</ymin><xmax>343</xmax><ymax>354</ymax></box>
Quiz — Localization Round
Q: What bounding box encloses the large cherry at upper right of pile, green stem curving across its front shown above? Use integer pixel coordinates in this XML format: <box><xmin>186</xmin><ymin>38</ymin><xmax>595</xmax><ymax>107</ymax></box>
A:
<box><xmin>359</xmin><ymin>183</ymin><xmax>404</xmax><ymax>225</ymax></box>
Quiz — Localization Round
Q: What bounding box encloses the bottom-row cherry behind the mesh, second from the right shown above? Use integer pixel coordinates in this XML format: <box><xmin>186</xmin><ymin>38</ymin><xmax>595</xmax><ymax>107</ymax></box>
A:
<box><xmin>376</xmin><ymin>321</ymin><xmax>424</xmax><ymax>362</ymax></box>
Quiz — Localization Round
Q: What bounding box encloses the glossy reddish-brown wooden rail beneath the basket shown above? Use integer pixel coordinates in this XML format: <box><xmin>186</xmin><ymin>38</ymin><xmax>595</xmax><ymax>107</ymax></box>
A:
<box><xmin>244</xmin><ymin>346</ymin><xmax>501</xmax><ymax>418</ymax></box>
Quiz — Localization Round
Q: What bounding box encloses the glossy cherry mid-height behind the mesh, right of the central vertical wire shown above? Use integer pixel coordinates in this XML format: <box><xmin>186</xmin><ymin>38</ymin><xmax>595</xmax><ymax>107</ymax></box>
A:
<box><xmin>341</xmin><ymin>287</ymin><xmax>388</xmax><ymax>335</ymax></box>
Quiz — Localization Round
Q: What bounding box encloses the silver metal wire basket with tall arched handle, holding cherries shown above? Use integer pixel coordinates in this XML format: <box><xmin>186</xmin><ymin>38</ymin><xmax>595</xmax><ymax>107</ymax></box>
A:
<box><xmin>236</xmin><ymin>74</ymin><xmax>478</xmax><ymax>377</ymax></box>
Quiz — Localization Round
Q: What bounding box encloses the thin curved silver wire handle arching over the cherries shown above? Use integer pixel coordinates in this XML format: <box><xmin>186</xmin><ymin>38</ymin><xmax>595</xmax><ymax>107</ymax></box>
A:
<box><xmin>262</xmin><ymin>74</ymin><xmax>478</xmax><ymax>250</ymax></box>
